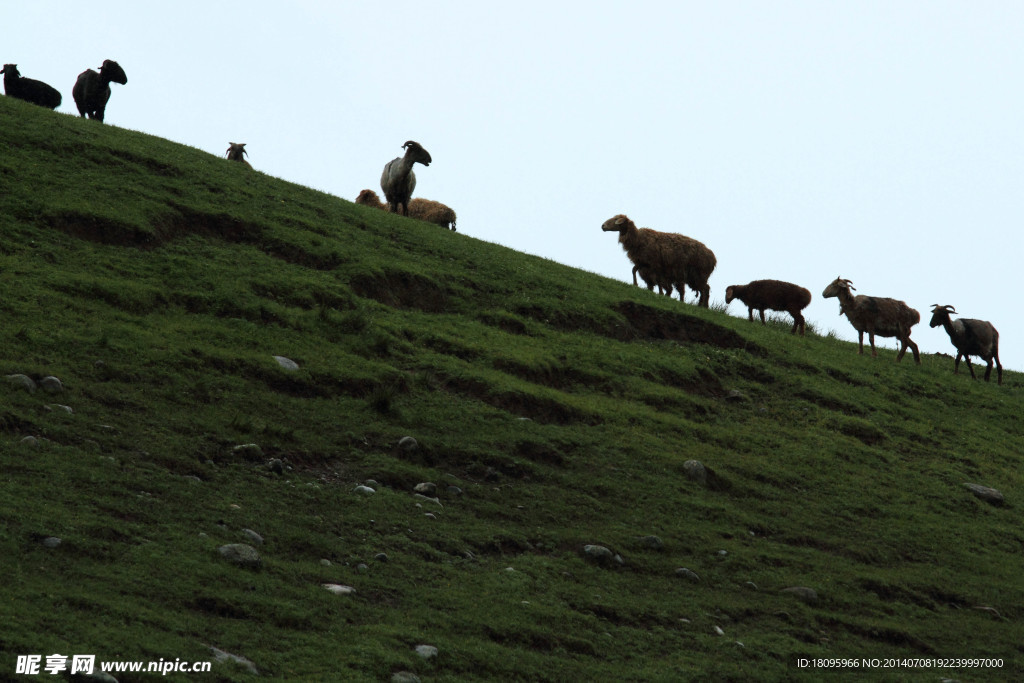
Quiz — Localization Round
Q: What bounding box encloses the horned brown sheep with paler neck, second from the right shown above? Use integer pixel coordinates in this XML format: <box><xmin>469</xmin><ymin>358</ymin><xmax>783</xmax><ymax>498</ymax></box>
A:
<box><xmin>821</xmin><ymin>278</ymin><xmax>921</xmax><ymax>365</ymax></box>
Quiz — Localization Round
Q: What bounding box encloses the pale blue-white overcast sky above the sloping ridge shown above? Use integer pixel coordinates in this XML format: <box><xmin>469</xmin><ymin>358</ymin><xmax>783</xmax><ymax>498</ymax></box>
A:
<box><xmin>8</xmin><ymin>0</ymin><xmax>1024</xmax><ymax>371</ymax></box>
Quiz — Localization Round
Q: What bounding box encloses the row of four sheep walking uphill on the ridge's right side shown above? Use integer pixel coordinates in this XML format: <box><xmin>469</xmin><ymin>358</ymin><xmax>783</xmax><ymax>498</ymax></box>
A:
<box><xmin>601</xmin><ymin>214</ymin><xmax>1002</xmax><ymax>384</ymax></box>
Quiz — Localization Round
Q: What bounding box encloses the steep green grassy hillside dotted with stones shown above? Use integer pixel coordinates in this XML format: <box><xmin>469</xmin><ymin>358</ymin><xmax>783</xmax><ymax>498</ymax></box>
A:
<box><xmin>0</xmin><ymin>97</ymin><xmax>1024</xmax><ymax>681</ymax></box>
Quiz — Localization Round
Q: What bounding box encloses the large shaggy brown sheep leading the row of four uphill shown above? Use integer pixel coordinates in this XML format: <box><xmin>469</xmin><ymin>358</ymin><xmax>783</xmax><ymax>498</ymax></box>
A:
<box><xmin>601</xmin><ymin>214</ymin><xmax>718</xmax><ymax>308</ymax></box>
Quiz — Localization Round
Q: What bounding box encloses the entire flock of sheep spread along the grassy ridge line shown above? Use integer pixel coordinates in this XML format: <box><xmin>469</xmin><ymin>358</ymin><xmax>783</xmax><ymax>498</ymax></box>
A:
<box><xmin>6</xmin><ymin>59</ymin><xmax>1002</xmax><ymax>384</ymax></box>
